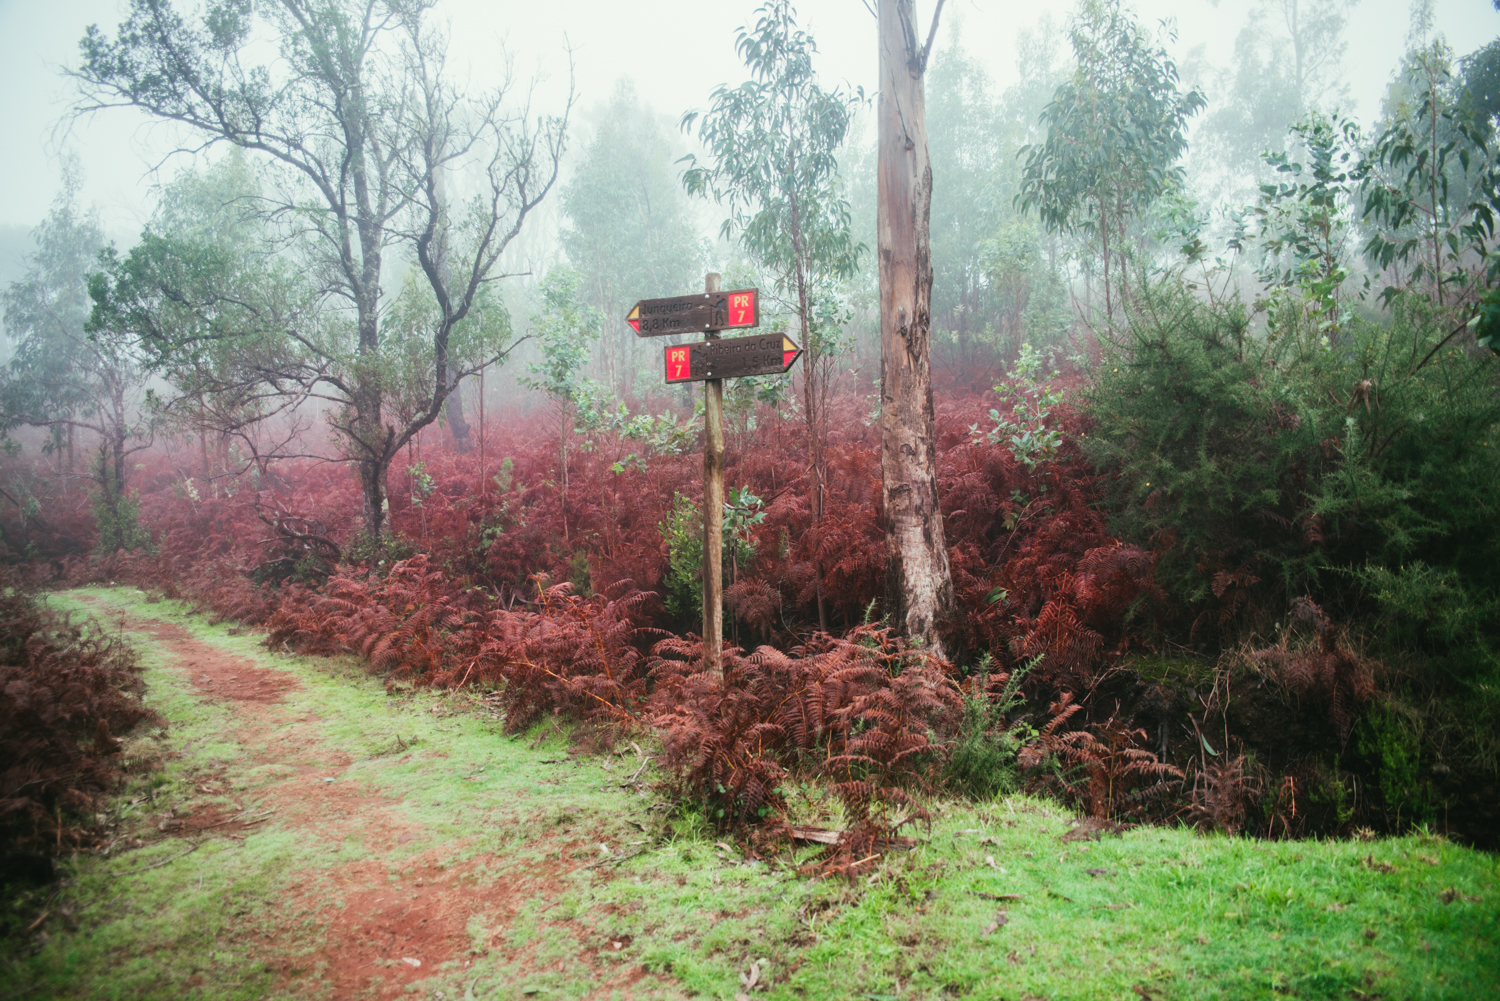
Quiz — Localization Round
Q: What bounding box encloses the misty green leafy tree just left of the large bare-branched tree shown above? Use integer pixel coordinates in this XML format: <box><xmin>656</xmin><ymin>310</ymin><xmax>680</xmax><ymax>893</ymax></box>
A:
<box><xmin>98</xmin><ymin>147</ymin><xmax>318</xmax><ymax>495</ymax></box>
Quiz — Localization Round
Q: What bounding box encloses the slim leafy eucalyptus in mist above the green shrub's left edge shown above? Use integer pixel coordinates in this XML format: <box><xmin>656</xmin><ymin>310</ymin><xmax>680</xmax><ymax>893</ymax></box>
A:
<box><xmin>1017</xmin><ymin>0</ymin><xmax>1205</xmax><ymax>323</ymax></box>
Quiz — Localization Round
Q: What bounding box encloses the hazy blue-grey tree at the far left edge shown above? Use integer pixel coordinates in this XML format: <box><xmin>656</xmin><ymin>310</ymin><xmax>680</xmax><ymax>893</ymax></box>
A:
<box><xmin>0</xmin><ymin>180</ymin><xmax>149</xmax><ymax>552</ymax></box>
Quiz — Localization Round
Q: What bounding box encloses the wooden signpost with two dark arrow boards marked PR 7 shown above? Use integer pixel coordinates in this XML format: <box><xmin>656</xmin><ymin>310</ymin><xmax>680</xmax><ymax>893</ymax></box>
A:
<box><xmin>626</xmin><ymin>275</ymin><xmax>803</xmax><ymax>681</ymax></box>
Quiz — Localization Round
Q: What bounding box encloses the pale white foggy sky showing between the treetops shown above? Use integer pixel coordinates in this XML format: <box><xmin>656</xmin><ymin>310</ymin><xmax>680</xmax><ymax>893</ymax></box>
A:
<box><xmin>0</xmin><ymin>0</ymin><xmax>1500</xmax><ymax>242</ymax></box>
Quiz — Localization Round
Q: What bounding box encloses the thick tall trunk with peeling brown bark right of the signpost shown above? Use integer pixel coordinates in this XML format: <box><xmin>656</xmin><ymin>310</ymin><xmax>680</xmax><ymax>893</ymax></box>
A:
<box><xmin>876</xmin><ymin>0</ymin><xmax>953</xmax><ymax>653</ymax></box>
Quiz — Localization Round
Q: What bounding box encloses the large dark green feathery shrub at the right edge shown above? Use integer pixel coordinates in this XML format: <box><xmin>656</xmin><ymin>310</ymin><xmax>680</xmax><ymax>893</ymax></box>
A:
<box><xmin>1085</xmin><ymin>281</ymin><xmax>1500</xmax><ymax>675</ymax></box>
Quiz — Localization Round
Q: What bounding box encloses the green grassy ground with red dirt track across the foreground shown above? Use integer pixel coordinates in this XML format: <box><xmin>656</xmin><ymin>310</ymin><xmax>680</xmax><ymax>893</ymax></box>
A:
<box><xmin>0</xmin><ymin>588</ymin><xmax>1500</xmax><ymax>1001</ymax></box>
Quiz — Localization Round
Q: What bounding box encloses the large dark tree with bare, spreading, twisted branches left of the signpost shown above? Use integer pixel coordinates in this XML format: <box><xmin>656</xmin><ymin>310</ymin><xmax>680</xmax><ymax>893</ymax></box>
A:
<box><xmin>71</xmin><ymin>0</ymin><xmax>572</xmax><ymax>537</ymax></box>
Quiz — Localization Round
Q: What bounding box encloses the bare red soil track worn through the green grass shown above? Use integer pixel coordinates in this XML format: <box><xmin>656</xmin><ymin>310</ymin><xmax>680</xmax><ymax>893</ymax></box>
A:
<box><xmin>80</xmin><ymin>596</ymin><xmax>671</xmax><ymax>1001</ymax></box>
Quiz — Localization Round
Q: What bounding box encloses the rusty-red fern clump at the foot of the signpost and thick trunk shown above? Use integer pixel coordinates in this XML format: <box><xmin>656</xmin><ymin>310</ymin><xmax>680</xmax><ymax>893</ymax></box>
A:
<box><xmin>651</xmin><ymin>626</ymin><xmax>962</xmax><ymax>866</ymax></box>
